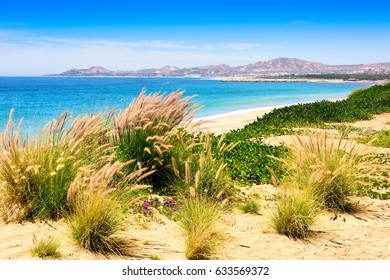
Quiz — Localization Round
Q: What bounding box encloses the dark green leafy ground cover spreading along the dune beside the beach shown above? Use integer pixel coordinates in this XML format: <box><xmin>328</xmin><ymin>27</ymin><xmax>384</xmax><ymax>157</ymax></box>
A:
<box><xmin>219</xmin><ymin>83</ymin><xmax>390</xmax><ymax>184</ymax></box>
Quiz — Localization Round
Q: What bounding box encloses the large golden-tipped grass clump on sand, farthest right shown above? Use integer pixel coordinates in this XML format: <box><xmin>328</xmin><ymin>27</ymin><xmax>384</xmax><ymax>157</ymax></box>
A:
<box><xmin>290</xmin><ymin>130</ymin><xmax>377</xmax><ymax>211</ymax></box>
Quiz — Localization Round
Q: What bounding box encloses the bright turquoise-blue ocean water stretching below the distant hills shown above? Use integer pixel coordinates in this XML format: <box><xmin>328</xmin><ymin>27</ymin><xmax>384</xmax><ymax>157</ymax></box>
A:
<box><xmin>0</xmin><ymin>77</ymin><xmax>371</xmax><ymax>135</ymax></box>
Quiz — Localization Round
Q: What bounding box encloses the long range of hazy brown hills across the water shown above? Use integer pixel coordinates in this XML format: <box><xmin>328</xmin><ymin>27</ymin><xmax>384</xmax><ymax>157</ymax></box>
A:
<box><xmin>47</xmin><ymin>57</ymin><xmax>390</xmax><ymax>77</ymax></box>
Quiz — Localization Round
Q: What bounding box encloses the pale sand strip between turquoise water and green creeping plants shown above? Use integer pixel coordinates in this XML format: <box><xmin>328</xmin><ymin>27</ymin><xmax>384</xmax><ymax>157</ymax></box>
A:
<box><xmin>193</xmin><ymin>97</ymin><xmax>347</xmax><ymax>134</ymax></box>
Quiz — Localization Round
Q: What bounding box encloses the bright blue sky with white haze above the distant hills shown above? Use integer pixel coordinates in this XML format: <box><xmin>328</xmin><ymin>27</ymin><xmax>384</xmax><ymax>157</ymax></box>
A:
<box><xmin>0</xmin><ymin>0</ymin><xmax>390</xmax><ymax>76</ymax></box>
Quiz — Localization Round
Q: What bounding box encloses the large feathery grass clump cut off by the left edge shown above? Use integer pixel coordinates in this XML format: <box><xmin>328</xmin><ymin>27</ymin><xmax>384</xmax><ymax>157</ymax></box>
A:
<box><xmin>0</xmin><ymin>111</ymin><xmax>112</xmax><ymax>221</ymax></box>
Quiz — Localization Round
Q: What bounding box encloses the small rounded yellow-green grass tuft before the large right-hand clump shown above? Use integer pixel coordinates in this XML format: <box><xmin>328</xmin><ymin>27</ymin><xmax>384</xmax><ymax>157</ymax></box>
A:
<box><xmin>271</xmin><ymin>187</ymin><xmax>319</xmax><ymax>239</ymax></box>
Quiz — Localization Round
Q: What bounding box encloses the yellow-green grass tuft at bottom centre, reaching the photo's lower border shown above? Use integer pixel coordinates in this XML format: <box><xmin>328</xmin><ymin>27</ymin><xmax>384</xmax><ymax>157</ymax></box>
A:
<box><xmin>179</xmin><ymin>189</ymin><xmax>225</xmax><ymax>260</ymax></box>
